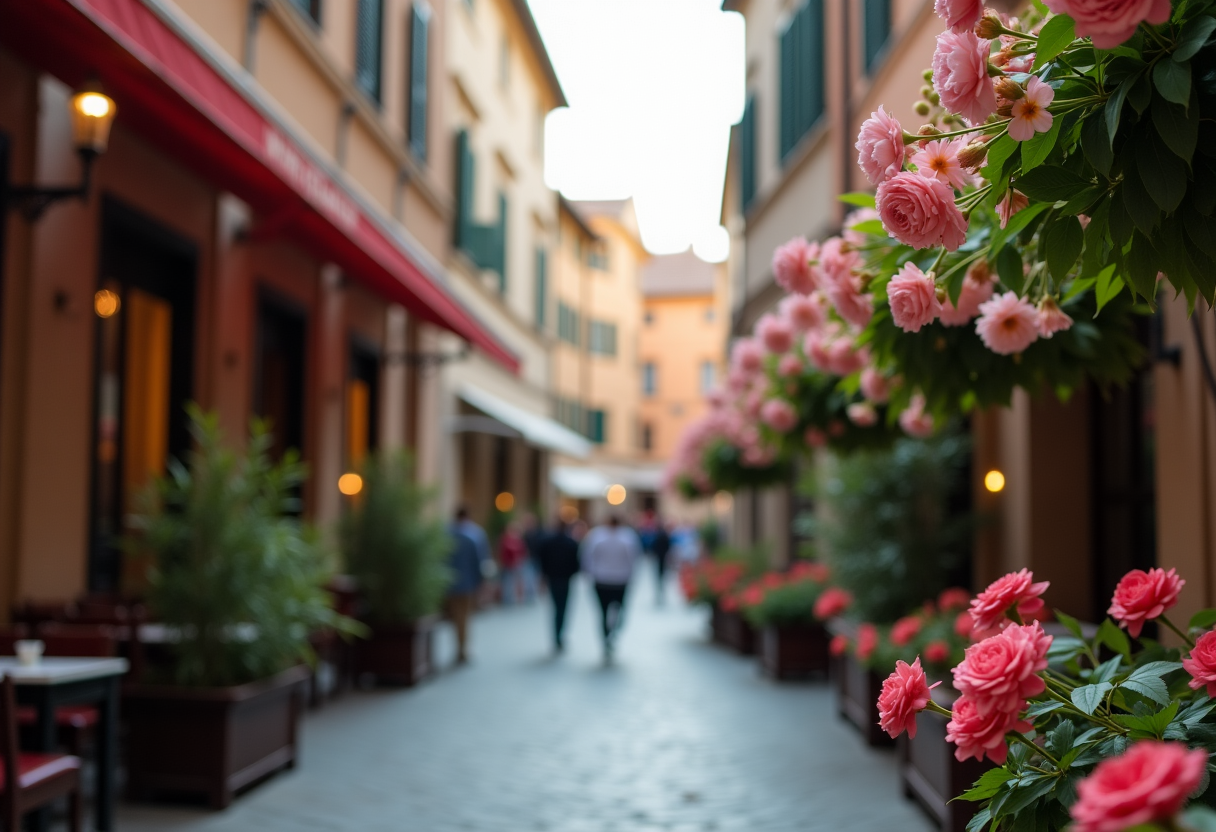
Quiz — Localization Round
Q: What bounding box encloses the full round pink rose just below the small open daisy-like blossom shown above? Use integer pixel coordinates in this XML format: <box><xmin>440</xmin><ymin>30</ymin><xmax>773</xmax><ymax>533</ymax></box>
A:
<box><xmin>876</xmin><ymin>170</ymin><xmax>967</xmax><ymax>252</ymax></box>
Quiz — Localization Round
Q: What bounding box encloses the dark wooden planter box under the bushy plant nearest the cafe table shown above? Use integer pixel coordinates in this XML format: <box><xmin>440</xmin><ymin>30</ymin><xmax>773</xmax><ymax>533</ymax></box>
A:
<box><xmin>123</xmin><ymin>667</ymin><xmax>309</xmax><ymax>809</ymax></box>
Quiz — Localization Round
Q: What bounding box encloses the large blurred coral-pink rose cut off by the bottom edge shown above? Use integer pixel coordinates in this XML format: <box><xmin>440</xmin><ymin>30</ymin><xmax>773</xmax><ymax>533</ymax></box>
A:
<box><xmin>1069</xmin><ymin>741</ymin><xmax>1207</xmax><ymax>832</ymax></box>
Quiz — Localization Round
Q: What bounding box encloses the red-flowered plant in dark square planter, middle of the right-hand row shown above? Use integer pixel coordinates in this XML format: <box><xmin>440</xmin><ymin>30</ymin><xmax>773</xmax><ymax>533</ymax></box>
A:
<box><xmin>739</xmin><ymin>561</ymin><xmax>848</xmax><ymax>679</ymax></box>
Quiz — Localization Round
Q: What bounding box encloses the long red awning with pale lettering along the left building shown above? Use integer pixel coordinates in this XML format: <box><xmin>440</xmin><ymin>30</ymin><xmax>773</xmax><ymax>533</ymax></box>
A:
<box><xmin>0</xmin><ymin>0</ymin><xmax>519</xmax><ymax>372</ymax></box>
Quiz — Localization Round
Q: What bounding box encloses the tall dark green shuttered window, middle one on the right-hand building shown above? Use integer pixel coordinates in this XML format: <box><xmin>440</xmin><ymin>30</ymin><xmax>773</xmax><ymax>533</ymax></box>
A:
<box><xmin>778</xmin><ymin>0</ymin><xmax>823</xmax><ymax>159</ymax></box>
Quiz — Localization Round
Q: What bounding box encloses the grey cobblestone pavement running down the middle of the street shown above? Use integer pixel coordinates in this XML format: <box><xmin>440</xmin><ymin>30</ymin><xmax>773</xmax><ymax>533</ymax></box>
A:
<box><xmin>118</xmin><ymin>564</ymin><xmax>931</xmax><ymax>832</ymax></box>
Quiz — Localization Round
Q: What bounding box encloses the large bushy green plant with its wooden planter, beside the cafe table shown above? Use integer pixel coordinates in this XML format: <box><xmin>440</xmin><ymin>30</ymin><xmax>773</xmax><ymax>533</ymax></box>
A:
<box><xmin>123</xmin><ymin>405</ymin><xmax>356</xmax><ymax>808</ymax></box>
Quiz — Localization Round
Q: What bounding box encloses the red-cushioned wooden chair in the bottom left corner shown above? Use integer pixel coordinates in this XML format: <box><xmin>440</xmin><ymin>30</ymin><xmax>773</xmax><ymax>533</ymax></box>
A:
<box><xmin>0</xmin><ymin>676</ymin><xmax>83</xmax><ymax>832</ymax></box>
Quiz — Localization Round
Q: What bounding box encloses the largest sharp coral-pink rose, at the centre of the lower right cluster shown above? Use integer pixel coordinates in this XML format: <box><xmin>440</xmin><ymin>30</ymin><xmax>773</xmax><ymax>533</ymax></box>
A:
<box><xmin>953</xmin><ymin>622</ymin><xmax>1052</xmax><ymax>715</ymax></box>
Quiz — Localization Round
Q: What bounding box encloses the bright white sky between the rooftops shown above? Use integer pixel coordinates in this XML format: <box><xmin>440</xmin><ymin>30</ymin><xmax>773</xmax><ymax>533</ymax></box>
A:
<box><xmin>528</xmin><ymin>0</ymin><xmax>745</xmax><ymax>262</ymax></box>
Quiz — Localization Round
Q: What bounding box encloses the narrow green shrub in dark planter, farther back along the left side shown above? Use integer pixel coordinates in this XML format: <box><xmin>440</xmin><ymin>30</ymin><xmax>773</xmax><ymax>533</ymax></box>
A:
<box><xmin>340</xmin><ymin>452</ymin><xmax>451</xmax><ymax>685</ymax></box>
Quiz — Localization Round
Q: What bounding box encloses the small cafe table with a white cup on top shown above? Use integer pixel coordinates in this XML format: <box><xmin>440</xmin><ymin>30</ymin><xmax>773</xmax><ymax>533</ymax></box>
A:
<box><xmin>0</xmin><ymin>656</ymin><xmax>128</xmax><ymax>832</ymax></box>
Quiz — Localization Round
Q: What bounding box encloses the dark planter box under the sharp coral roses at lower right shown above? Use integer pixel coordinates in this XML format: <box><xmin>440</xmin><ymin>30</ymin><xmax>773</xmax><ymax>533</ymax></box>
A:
<box><xmin>900</xmin><ymin>686</ymin><xmax>992</xmax><ymax>832</ymax></box>
